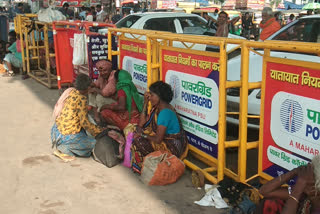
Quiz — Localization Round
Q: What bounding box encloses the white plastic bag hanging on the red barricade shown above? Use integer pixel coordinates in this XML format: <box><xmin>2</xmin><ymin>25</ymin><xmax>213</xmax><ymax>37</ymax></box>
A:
<box><xmin>72</xmin><ymin>33</ymin><xmax>88</xmax><ymax>65</ymax></box>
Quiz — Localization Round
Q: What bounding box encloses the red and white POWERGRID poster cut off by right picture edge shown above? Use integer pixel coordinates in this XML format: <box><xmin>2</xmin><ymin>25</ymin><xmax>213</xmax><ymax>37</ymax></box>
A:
<box><xmin>262</xmin><ymin>59</ymin><xmax>320</xmax><ymax>177</ymax></box>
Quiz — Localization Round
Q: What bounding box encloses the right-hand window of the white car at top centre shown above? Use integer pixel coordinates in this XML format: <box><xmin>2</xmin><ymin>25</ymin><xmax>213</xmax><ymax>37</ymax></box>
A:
<box><xmin>177</xmin><ymin>17</ymin><xmax>208</xmax><ymax>35</ymax></box>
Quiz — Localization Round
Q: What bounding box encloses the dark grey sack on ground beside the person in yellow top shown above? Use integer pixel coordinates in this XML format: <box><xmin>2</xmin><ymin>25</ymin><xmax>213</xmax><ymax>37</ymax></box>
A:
<box><xmin>92</xmin><ymin>130</ymin><xmax>120</xmax><ymax>168</ymax></box>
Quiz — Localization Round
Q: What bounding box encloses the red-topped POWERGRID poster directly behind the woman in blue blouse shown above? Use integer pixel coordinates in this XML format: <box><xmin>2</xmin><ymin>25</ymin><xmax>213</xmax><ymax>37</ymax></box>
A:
<box><xmin>161</xmin><ymin>47</ymin><xmax>219</xmax><ymax>158</ymax></box>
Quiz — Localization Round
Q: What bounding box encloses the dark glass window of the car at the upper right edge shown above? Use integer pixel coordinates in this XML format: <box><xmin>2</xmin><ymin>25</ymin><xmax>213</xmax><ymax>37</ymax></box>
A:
<box><xmin>272</xmin><ymin>19</ymin><xmax>320</xmax><ymax>43</ymax></box>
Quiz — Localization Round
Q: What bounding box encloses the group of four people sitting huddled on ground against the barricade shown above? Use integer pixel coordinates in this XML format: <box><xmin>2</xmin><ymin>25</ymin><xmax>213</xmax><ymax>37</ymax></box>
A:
<box><xmin>51</xmin><ymin>60</ymin><xmax>187</xmax><ymax>176</ymax></box>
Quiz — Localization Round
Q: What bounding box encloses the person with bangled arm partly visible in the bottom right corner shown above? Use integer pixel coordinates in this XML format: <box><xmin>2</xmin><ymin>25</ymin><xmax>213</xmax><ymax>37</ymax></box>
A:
<box><xmin>256</xmin><ymin>155</ymin><xmax>320</xmax><ymax>214</ymax></box>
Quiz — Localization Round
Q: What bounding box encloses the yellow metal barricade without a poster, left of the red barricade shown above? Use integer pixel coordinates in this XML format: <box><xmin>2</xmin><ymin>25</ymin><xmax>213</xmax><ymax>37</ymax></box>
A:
<box><xmin>15</xmin><ymin>14</ymin><xmax>57</xmax><ymax>88</ymax></box>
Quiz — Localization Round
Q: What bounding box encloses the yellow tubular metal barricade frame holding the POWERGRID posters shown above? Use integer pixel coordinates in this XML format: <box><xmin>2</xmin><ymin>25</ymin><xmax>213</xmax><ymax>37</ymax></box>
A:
<box><xmin>108</xmin><ymin>28</ymin><xmax>320</xmax><ymax>183</ymax></box>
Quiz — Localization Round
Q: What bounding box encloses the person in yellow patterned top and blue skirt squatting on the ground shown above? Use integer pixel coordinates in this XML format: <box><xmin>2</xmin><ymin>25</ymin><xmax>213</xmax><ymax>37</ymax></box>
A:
<box><xmin>51</xmin><ymin>74</ymin><xmax>103</xmax><ymax>161</ymax></box>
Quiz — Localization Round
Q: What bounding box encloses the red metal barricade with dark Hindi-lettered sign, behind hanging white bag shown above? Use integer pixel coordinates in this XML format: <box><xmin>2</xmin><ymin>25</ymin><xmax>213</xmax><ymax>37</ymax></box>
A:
<box><xmin>53</xmin><ymin>21</ymin><xmax>116</xmax><ymax>89</ymax></box>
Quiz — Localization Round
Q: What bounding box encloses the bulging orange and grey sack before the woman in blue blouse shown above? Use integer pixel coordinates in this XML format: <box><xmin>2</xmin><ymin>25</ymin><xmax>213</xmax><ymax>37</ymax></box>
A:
<box><xmin>141</xmin><ymin>151</ymin><xmax>185</xmax><ymax>185</ymax></box>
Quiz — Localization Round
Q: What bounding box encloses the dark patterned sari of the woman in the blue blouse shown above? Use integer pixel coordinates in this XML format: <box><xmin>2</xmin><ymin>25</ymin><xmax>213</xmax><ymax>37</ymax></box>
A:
<box><xmin>131</xmin><ymin>108</ymin><xmax>188</xmax><ymax>173</ymax></box>
